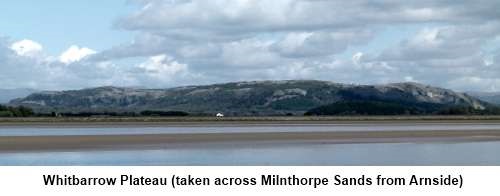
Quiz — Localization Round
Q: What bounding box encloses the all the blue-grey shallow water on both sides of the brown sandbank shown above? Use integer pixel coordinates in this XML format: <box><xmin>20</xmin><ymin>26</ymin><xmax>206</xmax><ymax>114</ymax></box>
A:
<box><xmin>0</xmin><ymin>123</ymin><xmax>500</xmax><ymax>166</ymax></box>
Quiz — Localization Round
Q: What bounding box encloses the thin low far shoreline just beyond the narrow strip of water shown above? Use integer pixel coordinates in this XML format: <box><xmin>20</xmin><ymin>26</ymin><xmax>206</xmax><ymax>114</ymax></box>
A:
<box><xmin>0</xmin><ymin>115</ymin><xmax>500</xmax><ymax>128</ymax></box>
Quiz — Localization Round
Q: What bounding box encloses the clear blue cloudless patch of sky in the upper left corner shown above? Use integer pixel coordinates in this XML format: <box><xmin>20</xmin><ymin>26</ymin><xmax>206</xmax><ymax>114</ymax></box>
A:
<box><xmin>0</xmin><ymin>0</ymin><xmax>136</xmax><ymax>53</ymax></box>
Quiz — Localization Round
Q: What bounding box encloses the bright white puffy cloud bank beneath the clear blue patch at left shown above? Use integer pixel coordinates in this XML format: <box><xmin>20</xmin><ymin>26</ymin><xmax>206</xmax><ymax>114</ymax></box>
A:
<box><xmin>0</xmin><ymin>38</ymin><xmax>203</xmax><ymax>90</ymax></box>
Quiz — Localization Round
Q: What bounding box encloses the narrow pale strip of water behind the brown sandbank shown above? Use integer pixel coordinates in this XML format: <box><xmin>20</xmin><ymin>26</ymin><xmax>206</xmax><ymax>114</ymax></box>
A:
<box><xmin>0</xmin><ymin>123</ymin><xmax>500</xmax><ymax>136</ymax></box>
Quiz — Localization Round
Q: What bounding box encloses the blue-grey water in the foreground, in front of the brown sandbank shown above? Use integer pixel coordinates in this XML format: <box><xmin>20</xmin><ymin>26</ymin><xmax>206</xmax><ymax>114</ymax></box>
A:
<box><xmin>0</xmin><ymin>142</ymin><xmax>500</xmax><ymax>165</ymax></box>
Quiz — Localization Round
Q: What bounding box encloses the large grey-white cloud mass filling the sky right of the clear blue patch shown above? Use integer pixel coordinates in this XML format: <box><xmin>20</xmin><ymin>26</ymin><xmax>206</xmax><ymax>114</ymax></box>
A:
<box><xmin>92</xmin><ymin>0</ymin><xmax>500</xmax><ymax>89</ymax></box>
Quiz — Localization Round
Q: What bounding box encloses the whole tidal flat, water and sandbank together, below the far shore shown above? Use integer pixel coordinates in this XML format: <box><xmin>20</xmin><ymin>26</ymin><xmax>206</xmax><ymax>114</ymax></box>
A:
<box><xmin>0</xmin><ymin>122</ymin><xmax>500</xmax><ymax>165</ymax></box>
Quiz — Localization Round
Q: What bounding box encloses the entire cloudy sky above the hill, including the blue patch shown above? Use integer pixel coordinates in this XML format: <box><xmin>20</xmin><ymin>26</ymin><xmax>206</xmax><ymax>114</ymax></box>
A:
<box><xmin>0</xmin><ymin>0</ymin><xmax>500</xmax><ymax>91</ymax></box>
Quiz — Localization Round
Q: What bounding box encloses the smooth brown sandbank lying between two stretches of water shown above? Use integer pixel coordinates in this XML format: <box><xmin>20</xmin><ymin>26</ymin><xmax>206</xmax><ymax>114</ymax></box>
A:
<box><xmin>0</xmin><ymin>130</ymin><xmax>500</xmax><ymax>152</ymax></box>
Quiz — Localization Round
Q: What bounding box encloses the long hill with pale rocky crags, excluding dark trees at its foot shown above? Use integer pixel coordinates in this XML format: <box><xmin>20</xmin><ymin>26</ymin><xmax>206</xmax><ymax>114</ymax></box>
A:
<box><xmin>10</xmin><ymin>80</ymin><xmax>489</xmax><ymax>116</ymax></box>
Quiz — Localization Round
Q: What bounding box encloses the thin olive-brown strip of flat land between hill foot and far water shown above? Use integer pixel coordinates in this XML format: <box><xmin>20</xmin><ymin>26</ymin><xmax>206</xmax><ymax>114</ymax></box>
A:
<box><xmin>0</xmin><ymin>116</ymin><xmax>500</xmax><ymax>125</ymax></box>
